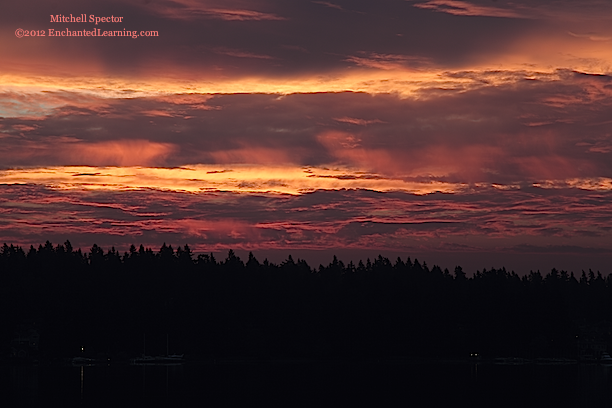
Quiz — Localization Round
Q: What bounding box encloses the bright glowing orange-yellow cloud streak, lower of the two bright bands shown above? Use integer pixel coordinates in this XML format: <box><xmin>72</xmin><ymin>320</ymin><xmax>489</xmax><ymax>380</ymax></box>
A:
<box><xmin>0</xmin><ymin>165</ymin><xmax>466</xmax><ymax>195</ymax></box>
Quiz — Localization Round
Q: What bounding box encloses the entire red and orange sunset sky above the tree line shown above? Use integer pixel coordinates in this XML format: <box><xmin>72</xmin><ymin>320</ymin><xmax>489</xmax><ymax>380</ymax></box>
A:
<box><xmin>0</xmin><ymin>0</ymin><xmax>612</xmax><ymax>275</ymax></box>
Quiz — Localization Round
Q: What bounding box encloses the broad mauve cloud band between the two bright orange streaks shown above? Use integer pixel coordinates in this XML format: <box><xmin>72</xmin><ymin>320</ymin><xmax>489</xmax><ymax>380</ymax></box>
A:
<box><xmin>0</xmin><ymin>71</ymin><xmax>612</xmax><ymax>181</ymax></box>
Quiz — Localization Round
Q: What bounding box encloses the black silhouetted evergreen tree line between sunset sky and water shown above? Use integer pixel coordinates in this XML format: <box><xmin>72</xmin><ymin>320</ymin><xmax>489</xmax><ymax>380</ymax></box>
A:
<box><xmin>0</xmin><ymin>241</ymin><xmax>612</xmax><ymax>359</ymax></box>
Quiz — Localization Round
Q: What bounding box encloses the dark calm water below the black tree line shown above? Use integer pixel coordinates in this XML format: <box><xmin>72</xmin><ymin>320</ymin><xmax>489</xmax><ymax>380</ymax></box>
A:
<box><xmin>0</xmin><ymin>363</ymin><xmax>612</xmax><ymax>407</ymax></box>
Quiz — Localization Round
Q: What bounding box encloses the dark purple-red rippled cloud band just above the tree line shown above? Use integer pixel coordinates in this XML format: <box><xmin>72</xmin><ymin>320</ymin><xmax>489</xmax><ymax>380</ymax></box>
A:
<box><xmin>0</xmin><ymin>183</ymin><xmax>612</xmax><ymax>262</ymax></box>
